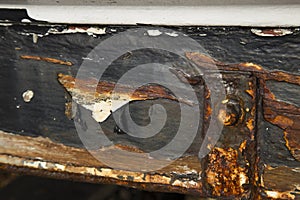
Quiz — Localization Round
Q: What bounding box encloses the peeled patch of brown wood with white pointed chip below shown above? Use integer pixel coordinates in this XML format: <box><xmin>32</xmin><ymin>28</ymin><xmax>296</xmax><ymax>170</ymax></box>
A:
<box><xmin>58</xmin><ymin>73</ymin><xmax>193</xmax><ymax>122</ymax></box>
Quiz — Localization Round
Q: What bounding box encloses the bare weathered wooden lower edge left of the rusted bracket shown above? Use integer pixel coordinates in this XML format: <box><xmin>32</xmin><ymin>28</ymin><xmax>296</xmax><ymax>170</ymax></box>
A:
<box><xmin>0</xmin><ymin>131</ymin><xmax>203</xmax><ymax>195</ymax></box>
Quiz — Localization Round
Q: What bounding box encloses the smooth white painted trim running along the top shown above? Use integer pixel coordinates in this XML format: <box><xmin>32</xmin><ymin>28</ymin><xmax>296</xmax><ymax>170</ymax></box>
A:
<box><xmin>0</xmin><ymin>3</ymin><xmax>300</xmax><ymax>26</ymax></box>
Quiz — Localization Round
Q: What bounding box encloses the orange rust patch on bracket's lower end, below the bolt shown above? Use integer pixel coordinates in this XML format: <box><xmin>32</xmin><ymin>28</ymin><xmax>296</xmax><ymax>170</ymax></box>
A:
<box><xmin>206</xmin><ymin>148</ymin><xmax>249</xmax><ymax>196</ymax></box>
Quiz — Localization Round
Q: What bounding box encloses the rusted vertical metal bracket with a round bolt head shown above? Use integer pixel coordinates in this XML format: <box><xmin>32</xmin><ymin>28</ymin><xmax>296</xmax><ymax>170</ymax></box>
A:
<box><xmin>205</xmin><ymin>72</ymin><xmax>257</xmax><ymax>198</ymax></box>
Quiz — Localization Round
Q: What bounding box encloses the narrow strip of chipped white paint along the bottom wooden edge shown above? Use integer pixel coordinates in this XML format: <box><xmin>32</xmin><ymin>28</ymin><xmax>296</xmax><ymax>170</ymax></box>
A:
<box><xmin>0</xmin><ymin>155</ymin><xmax>201</xmax><ymax>189</ymax></box>
